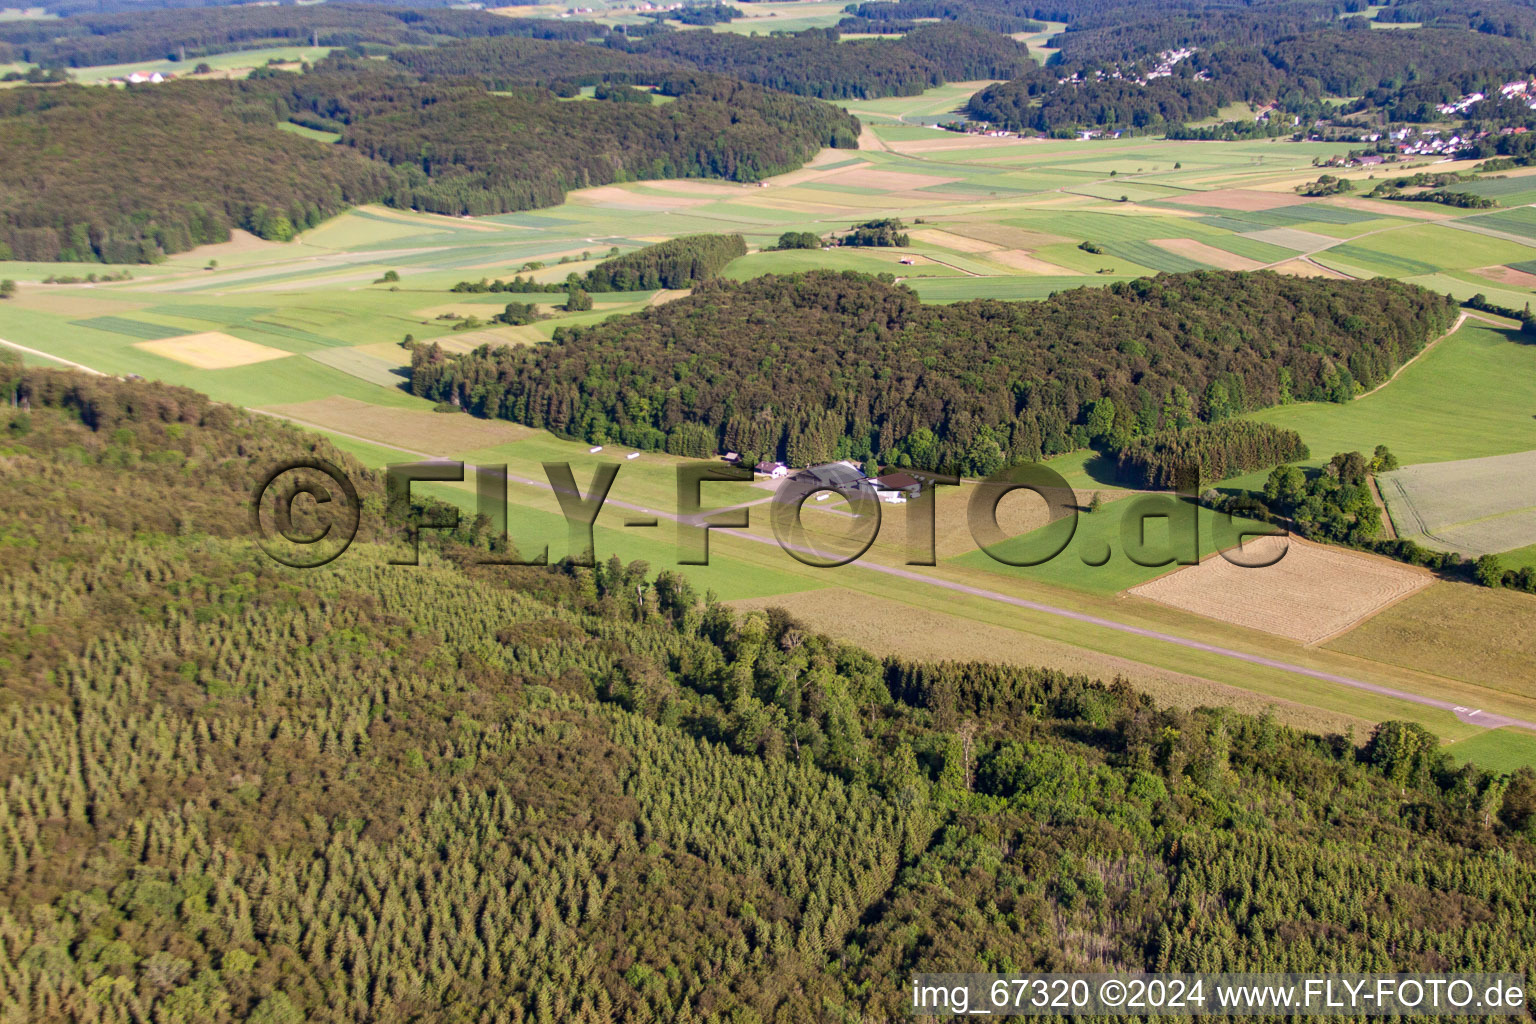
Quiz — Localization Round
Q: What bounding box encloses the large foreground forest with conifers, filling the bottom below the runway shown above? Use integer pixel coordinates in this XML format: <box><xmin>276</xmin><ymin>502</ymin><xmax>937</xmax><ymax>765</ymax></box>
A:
<box><xmin>0</xmin><ymin>360</ymin><xmax>1536</xmax><ymax>1024</ymax></box>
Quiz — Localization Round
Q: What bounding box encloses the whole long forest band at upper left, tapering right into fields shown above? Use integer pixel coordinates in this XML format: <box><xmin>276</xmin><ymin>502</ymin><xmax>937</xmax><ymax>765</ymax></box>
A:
<box><xmin>0</xmin><ymin>53</ymin><xmax>859</xmax><ymax>263</ymax></box>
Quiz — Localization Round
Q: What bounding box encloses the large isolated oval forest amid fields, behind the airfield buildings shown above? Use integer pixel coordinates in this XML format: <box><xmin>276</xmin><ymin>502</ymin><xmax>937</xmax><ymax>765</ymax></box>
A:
<box><xmin>412</xmin><ymin>270</ymin><xmax>1456</xmax><ymax>474</ymax></box>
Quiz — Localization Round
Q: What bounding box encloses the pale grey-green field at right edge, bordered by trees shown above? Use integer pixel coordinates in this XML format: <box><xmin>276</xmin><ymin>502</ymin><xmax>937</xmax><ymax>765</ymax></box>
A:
<box><xmin>1376</xmin><ymin>451</ymin><xmax>1536</xmax><ymax>556</ymax></box>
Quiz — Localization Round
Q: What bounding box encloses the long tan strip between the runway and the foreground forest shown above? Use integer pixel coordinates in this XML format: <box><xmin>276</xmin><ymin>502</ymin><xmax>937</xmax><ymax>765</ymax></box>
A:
<box><xmin>730</xmin><ymin>588</ymin><xmax>1375</xmax><ymax>735</ymax></box>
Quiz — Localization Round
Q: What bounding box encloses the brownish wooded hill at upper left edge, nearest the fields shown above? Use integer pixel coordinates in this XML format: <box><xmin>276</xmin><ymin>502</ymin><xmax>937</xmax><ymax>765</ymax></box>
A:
<box><xmin>0</xmin><ymin>81</ymin><xmax>392</xmax><ymax>263</ymax></box>
